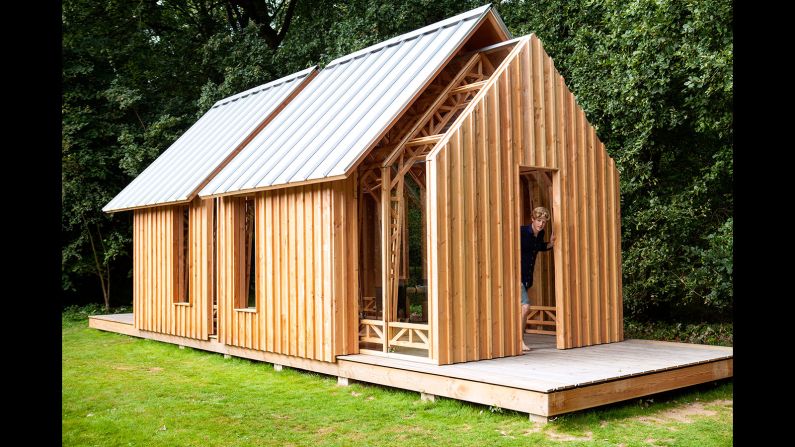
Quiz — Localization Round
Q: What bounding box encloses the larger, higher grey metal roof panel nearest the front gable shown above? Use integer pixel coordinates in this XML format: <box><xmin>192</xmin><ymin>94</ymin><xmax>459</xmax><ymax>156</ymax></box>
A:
<box><xmin>199</xmin><ymin>5</ymin><xmax>491</xmax><ymax>197</ymax></box>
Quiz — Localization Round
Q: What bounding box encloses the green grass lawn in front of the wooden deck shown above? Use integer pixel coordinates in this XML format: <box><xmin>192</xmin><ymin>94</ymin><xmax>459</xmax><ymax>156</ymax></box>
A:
<box><xmin>62</xmin><ymin>312</ymin><xmax>733</xmax><ymax>447</ymax></box>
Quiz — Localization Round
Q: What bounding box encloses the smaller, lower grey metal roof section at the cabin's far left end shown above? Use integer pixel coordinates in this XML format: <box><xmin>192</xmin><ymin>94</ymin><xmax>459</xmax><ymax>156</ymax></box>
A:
<box><xmin>102</xmin><ymin>67</ymin><xmax>315</xmax><ymax>212</ymax></box>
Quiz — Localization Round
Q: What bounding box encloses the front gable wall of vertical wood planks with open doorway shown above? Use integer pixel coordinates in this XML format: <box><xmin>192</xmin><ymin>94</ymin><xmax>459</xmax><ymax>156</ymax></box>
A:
<box><xmin>427</xmin><ymin>35</ymin><xmax>623</xmax><ymax>364</ymax></box>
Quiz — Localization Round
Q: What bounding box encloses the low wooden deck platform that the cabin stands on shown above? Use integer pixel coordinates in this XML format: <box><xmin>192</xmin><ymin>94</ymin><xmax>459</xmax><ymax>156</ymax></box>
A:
<box><xmin>89</xmin><ymin>314</ymin><xmax>734</xmax><ymax>421</ymax></box>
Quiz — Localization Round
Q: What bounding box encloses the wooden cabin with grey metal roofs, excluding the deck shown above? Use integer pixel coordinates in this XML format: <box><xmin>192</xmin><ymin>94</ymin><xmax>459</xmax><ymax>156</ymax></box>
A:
<box><xmin>103</xmin><ymin>5</ymin><xmax>623</xmax><ymax>365</ymax></box>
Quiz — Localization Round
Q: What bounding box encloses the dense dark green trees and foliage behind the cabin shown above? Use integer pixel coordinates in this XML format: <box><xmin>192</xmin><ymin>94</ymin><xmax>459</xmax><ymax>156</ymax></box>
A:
<box><xmin>61</xmin><ymin>0</ymin><xmax>734</xmax><ymax>321</ymax></box>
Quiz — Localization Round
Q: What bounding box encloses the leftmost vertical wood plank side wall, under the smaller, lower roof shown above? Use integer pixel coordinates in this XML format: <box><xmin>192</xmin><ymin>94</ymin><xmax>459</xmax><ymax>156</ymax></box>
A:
<box><xmin>133</xmin><ymin>198</ymin><xmax>213</xmax><ymax>340</ymax></box>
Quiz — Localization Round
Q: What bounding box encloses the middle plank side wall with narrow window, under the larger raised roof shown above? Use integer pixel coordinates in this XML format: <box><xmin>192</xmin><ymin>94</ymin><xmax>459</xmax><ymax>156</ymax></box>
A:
<box><xmin>218</xmin><ymin>178</ymin><xmax>358</xmax><ymax>362</ymax></box>
